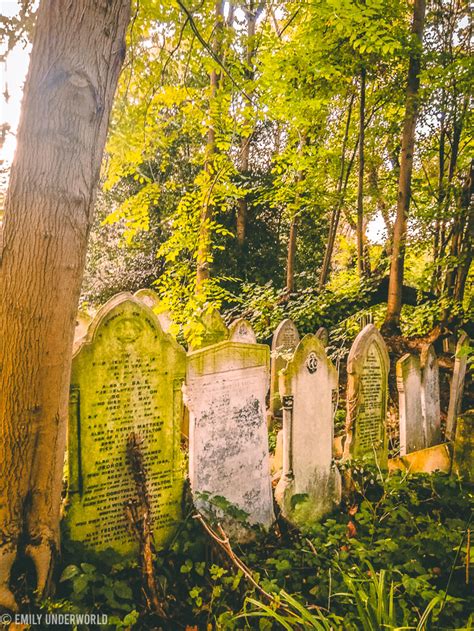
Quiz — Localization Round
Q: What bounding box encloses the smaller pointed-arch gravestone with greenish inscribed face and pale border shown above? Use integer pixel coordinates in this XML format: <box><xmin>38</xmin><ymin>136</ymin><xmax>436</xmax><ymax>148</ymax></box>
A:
<box><xmin>344</xmin><ymin>324</ymin><xmax>390</xmax><ymax>468</ymax></box>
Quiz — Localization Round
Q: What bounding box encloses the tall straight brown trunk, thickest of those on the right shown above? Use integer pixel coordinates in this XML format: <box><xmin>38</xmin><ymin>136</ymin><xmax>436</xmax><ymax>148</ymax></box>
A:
<box><xmin>382</xmin><ymin>0</ymin><xmax>426</xmax><ymax>335</ymax></box>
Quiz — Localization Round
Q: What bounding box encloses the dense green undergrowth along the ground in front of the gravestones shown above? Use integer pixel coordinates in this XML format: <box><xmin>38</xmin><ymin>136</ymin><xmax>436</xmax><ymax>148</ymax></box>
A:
<box><xmin>43</xmin><ymin>466</ymin><xmax>474</xmax><ymax>631</ymax></box>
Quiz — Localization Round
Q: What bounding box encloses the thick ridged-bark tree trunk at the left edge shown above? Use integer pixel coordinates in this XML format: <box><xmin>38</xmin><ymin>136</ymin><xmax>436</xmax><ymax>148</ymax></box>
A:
<box><xmin>0</xmin><ymin>0</ymin><xmax>130</xmax><ymax>609</ymax></box>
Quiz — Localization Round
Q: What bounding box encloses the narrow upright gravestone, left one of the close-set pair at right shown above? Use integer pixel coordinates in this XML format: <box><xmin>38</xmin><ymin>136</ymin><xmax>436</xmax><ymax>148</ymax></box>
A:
<box><xmin>396</xmin><ymin>353</ymin><xmax>426</xmax><ymax>456</ymax></box>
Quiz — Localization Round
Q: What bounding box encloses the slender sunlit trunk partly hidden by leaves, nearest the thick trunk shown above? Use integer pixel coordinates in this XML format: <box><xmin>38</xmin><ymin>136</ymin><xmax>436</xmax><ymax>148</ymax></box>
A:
<box><xmin>196</xmin><ymin>0</ymin><xmax>224</xmax><ymax>294</ymax></box>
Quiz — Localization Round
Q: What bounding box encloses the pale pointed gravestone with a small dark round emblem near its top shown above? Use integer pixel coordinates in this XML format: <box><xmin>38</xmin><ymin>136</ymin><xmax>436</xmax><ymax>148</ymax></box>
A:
<box><xmin>275</xmin><ymin>335</ymin><xmax>341</xmax><ymax>527</ymax></box>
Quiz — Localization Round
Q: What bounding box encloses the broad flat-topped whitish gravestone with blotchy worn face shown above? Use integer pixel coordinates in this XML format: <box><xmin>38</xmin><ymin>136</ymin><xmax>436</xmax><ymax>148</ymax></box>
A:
<box><xmin>185</xmin><ymin>341</ymin><xmax>274</xmax><ymax>541</ymax></box>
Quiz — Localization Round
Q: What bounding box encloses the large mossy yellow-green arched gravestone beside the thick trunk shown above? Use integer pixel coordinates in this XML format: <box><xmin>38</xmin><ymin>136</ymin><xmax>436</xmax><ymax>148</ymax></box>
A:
<box><xmin>66</xmin><ymin>293</ymin><xmax>186</xmax><ymax>556</ymax></box>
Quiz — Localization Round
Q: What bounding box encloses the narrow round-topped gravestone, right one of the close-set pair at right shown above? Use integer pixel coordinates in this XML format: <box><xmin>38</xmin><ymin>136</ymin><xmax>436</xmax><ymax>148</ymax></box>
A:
<box><xmin>420</xmin><ymin>344</ymin><xmax>441</xmax><ymax>447</ymax></box>
